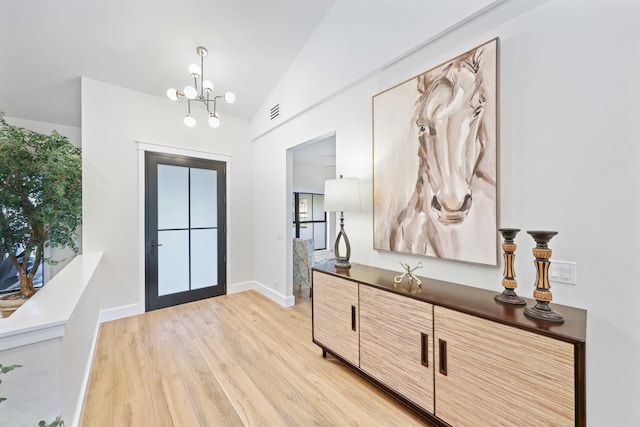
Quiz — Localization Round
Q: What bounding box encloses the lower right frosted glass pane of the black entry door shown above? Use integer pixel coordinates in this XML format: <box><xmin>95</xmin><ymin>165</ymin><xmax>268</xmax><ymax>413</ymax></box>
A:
<box><xmin>191</xmin><ymin>229</ymin><xmax>218</xmax><ymax>289</ymax></box>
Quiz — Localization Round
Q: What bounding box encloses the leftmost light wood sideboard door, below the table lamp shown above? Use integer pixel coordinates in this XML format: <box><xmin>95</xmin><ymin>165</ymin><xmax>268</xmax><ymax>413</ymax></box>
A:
<box><xmin>312</xmin><ymin>271</ymin><xmax>360</xmax><ymax>367</ymax></box>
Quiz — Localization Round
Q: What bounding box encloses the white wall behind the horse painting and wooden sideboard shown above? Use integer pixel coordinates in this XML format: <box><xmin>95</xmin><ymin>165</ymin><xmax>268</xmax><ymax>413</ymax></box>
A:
<box><xmin>254</xmin><ymin>0</ymin><xmax>640</xmax><ymax>426</ymax></box>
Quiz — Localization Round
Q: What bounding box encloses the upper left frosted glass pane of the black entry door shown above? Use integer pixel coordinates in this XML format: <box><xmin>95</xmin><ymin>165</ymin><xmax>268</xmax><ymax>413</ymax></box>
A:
<box><xmin>158</xmin><ymin>165</ymin><xmax>189</xmax><ymax>230</ymax></box>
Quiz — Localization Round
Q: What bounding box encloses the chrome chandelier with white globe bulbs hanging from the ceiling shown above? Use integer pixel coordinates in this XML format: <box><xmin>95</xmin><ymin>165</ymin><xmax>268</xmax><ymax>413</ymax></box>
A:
<box><xmin>167</xmin><ymin>47</ymin><xmax>236</xmax><ymax>128</ymax></box>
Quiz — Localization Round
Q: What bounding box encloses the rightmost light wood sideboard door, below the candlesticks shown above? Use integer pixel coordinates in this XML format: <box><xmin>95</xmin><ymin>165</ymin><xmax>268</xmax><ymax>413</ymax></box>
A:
<box><xmin>434</xmin><ymin>307</ymin><xmax>575</xmax><ymax>427</ymax></box>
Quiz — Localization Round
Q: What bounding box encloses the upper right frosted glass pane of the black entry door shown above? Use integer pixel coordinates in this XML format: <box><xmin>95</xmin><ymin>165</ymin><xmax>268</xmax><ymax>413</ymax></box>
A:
<box><xmin>191</xmin><ymin>168</ymin><xmax>218</xmax><ymax>228</ymax></box>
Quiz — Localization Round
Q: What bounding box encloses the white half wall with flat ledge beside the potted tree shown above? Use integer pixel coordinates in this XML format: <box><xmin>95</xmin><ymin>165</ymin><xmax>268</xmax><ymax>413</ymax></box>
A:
<box><xmin>0</xmin><ymin>254</ymin><xmax>101</xmax><ymax>427</ymax></box>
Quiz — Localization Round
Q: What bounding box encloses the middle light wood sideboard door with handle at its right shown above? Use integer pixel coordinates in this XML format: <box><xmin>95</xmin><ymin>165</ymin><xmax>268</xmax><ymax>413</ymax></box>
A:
<box><xmin>360</xmin><ymin>285</ymin><xmax>434</xmax><ymax>413</ymax></box>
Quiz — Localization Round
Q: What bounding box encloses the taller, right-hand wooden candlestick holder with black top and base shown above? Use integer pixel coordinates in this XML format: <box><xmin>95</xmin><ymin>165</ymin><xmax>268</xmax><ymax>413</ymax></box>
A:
<box><xmin>524</xmin><ymin>231</ymin><xmax>564</xmax><ymax>323</ymax></box>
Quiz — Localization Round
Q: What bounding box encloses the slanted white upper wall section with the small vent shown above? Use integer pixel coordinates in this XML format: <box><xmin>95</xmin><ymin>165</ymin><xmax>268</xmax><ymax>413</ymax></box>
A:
<box><xmin>251</xmin><ymin>0</ymin><xmax>502</xmax><ymax>136</ymax></box>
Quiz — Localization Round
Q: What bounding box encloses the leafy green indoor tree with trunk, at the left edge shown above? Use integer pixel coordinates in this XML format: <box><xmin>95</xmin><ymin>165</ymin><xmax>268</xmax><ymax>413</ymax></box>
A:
<box><xmin>0</xmin><ymin>111</ymin><xmax>82</xmax><ymax>298</ymax></box>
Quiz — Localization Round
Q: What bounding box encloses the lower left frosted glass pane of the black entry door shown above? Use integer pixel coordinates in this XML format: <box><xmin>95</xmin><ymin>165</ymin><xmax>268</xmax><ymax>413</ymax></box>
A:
<box><xmin>157</xmin><ymin>230</ymin><xmax>189</xmax><ymax>296</ymax></box>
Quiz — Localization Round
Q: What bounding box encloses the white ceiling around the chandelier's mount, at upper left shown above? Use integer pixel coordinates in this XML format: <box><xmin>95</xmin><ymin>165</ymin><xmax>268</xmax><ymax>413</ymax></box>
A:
<box><xmin>0</xmin><ymin>0</ymin><xmax>336</xmax><ymax>126</ymax></box>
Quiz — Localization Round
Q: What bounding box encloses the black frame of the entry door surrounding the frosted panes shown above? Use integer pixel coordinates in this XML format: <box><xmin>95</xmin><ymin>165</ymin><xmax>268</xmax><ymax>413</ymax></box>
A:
<box><xmin>144</xmin><ymin>151</ymin><xmax>227</xmax><ymax>311</ymax></box>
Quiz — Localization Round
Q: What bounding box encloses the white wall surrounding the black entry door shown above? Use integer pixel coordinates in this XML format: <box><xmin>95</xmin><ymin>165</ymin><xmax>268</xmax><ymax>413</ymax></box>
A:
<box><xmin>82</xmin><ymin>78</ymin><xmax>253</xmax><ymax>317</ymax></box>
